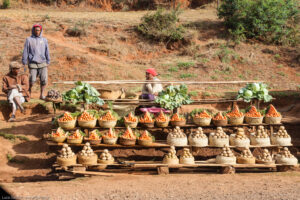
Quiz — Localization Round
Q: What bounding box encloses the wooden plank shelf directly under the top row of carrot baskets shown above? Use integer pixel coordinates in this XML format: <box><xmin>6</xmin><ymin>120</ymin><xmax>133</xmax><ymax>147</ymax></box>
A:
<box><xmin>52</xmin><ymin>123</ymin><xmax>283</xmax><ymax>131</ymax></box>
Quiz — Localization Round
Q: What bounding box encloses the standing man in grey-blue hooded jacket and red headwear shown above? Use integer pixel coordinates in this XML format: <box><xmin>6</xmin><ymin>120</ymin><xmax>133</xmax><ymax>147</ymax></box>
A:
<box><xmin>22</xmin><ymin>24</ymin><xmax>50</xmax><ymax>100</ymax></box>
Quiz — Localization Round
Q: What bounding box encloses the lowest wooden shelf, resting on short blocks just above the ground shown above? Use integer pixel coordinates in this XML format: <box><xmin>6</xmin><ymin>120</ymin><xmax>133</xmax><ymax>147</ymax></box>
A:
<box><xmin>52</xmin><ymin>161</ymin><xmax>299</xmax><ymax>176</ymax></box>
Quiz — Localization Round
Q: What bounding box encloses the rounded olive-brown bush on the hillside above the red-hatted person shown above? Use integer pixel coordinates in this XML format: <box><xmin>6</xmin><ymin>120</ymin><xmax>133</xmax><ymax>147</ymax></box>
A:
<box><xmin>137</xmin><ymin>7</ymin><xmax>185</xmax><ymax>42</ymax></box>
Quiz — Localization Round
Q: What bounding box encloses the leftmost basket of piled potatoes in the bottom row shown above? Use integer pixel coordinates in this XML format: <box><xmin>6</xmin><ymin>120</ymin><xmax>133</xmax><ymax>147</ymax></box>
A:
<box><xmin>56</xmin><ymin>144</ymin><xmax>77</xmax><ymax>166</ymax></box>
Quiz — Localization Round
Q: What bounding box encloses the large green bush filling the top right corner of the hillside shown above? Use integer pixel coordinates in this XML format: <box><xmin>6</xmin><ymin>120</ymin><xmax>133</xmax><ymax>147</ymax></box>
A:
<box><xmin>218</xmin><ymin>0</ymin><xmax>299</xmax><ymax>44</ymax></box>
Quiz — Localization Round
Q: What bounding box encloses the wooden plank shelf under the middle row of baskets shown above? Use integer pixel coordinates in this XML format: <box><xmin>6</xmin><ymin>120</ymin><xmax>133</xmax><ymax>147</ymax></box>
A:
<box><xmin>46</xmin><ymin>140</ymin><xmax>293</xmax><ymax>148</ymax></box>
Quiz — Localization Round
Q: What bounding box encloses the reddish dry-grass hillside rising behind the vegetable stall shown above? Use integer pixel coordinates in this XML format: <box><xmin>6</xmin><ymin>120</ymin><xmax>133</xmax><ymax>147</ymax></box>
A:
<box><xmin>0</xmin><ymin>5</ymin><xmax>300</xmax><ymax>96</ymax></box>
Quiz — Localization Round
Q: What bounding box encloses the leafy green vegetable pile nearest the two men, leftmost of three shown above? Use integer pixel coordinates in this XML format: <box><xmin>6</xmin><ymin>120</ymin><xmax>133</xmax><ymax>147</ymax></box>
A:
<box><xmin>62</xmin><ymin>81</ymin><xmax>104</xmax><ymax>106</ymax></box>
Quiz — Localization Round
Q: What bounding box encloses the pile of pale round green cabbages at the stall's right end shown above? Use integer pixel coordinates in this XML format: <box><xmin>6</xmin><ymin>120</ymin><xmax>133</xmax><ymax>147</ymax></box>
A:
<box><xmin>237</xmin><ymin>83</ymin><xmax>272</xmax><ymax>102</ymax></box>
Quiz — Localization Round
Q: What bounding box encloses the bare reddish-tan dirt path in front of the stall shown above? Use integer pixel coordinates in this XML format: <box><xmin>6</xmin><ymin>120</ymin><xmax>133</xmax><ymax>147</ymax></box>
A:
<box><xmin>3</xmin><ymin>172</ymin><xmax>300</xmax><ymax>200</ymax></box>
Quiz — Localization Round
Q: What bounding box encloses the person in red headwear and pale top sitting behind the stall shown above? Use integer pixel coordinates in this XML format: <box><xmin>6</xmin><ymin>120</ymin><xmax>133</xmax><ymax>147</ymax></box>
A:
<box><xmin>141</xmin><ymin>68</ymin><xmax>163</xmax><ymax>100</ymax></box>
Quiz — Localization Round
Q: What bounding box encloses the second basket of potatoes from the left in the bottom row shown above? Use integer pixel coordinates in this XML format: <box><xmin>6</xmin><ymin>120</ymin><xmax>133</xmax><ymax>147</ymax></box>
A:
<box><xmin>78</xmin><ymin>142</ymin><xmax>98</xmax><ymax>165</ymax></box>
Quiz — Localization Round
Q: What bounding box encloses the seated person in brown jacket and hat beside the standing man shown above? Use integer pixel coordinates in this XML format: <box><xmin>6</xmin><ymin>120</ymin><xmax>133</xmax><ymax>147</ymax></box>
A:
<box><xmin>2</xmin><ymin>62</ymin><xmax>29</xmax><ymax>122</ymax></box>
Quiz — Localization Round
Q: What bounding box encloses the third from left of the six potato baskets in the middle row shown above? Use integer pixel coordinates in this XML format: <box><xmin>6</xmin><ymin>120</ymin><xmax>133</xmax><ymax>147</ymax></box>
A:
<box><xmin>209</xmin><ymin>127</ymin><xmax>229</xmax><ymax>147</ymax></box>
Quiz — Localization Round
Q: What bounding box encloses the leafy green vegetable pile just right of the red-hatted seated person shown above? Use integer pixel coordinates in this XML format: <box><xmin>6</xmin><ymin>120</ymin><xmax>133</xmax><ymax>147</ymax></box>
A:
<box><xmin>155</xmin><ymin>85</ymin><xmax>192</xmax><ymax>110</ymax></box>
